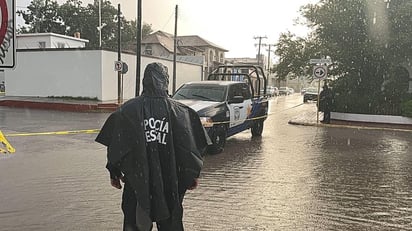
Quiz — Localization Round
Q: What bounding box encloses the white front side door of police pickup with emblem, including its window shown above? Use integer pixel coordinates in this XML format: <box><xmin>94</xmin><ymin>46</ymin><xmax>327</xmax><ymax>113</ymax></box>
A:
<box><xmin>228</xmin><ymin>83</ymin><xmax>252</xmax><ymax>127</ymax></box>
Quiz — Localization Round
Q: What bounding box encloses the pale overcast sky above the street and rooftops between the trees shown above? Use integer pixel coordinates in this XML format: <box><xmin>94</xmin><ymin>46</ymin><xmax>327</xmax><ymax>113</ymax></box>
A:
<box><xmin>16</xmin><ymin>0</ymin><xmax>317</xmax><ymax>57</ymax></box>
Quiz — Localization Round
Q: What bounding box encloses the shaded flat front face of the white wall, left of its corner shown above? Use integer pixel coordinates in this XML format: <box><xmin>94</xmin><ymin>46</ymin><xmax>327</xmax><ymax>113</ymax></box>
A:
<box><xmin>5</xmin><ymin>50</ymin><xmax>101</xmax><ymax>98</ymax></box>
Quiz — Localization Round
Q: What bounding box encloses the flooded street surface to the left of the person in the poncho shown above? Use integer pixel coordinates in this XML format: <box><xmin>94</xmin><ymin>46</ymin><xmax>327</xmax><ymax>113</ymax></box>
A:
<box><xmin>0</xmin><ymin>108</ymin><xmax>123</xmax><ymax>230</ymax></box>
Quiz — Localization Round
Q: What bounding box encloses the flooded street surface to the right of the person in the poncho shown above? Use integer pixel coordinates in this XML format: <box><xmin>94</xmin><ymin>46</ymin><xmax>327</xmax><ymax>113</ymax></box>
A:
<box><xmin>185</xmin><ymin>94</ymin><xmax>412</xmax><ymax>230</ymax></box>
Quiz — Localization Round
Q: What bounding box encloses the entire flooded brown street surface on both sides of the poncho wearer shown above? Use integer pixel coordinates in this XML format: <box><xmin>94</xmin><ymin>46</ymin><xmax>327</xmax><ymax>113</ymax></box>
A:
<box><xmin>0</xmin><ymin>94</ymin><xmax>412</xmax><ymax>231</ymax></box>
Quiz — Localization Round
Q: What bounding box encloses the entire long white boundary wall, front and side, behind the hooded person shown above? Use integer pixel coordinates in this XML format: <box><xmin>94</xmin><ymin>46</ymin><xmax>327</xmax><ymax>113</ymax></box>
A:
<box><xmin>5</xmin><ymin>50</ymin><xmax>202</xmax><ymax>102</ymax></box>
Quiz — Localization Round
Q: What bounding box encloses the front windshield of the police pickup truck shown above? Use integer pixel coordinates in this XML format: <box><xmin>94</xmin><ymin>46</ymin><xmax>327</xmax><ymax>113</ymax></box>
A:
<box><xmin>173</xmin><ymin>85</ymin><xmax>226</xmax><ymax>102</ymax></box>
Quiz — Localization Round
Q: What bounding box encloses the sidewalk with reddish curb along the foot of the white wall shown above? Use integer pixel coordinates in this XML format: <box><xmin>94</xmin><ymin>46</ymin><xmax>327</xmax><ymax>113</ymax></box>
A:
<box><xmin>0</xmin><ymin>96</ymin><xmax>118</xmax><ymax>112</ymax></box>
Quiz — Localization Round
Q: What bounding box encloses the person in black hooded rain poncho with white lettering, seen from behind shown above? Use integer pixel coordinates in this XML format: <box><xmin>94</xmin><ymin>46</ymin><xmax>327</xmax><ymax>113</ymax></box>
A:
<box><xmin>96</xmin><ymin>63</ymin><xmax>209</xmax><ymax>231</ymax></box>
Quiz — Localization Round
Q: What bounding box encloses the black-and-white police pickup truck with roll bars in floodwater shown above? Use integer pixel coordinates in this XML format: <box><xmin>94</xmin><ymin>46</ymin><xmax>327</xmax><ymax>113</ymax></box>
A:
<box><xmin>173</xmin><ymin>65</ymin><xmax>268</xmax><ymax>154</ymax></box>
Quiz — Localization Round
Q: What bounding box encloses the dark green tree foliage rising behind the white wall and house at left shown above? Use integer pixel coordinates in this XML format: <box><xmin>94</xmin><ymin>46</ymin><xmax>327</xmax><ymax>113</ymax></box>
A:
<box><xmin>18</xmin><ymin>0</ymin><xmax>152</xmax><ymax>52</ymax></box>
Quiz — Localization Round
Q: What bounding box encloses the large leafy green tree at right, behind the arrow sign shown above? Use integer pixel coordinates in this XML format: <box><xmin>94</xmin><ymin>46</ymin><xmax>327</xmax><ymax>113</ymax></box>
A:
<box><xmin>277</xmin><ymin>0</ymin><xmax>412</xmax><ymax>114</ymax></box>
